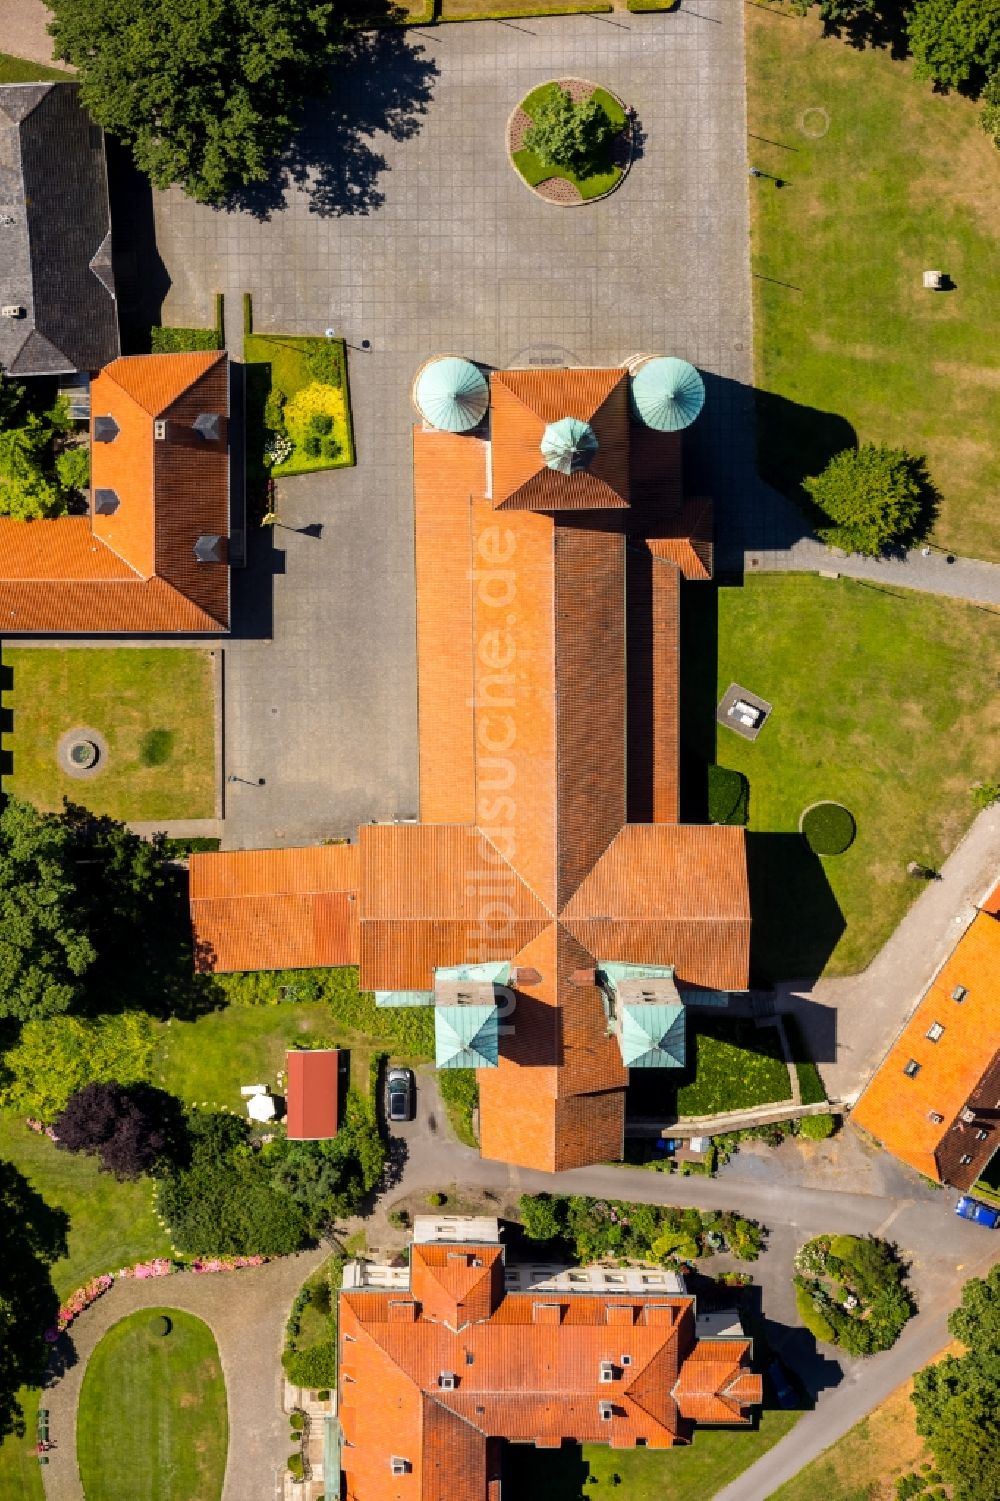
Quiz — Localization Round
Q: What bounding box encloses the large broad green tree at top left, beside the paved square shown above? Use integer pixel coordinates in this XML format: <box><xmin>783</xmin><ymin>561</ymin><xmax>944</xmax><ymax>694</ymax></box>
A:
<box><xmin>51</xmin><ymin>0</ymin><xmax>358</xmax><ymax>203</ymax></box>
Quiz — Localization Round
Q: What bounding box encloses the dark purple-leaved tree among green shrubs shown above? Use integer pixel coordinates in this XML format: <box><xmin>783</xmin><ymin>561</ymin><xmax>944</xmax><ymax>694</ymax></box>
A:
<box><xmin>54</xmin><ymin>1084</ymin><xmax>185</xmax><ymax>1180</ymax></box>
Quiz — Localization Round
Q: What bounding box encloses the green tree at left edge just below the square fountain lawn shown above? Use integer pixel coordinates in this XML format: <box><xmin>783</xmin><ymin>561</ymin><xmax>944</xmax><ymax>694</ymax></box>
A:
<box><xmin>0</xmin><ymin>799</ymin><xmax>96</xmax><ymax>1021</ymax></box>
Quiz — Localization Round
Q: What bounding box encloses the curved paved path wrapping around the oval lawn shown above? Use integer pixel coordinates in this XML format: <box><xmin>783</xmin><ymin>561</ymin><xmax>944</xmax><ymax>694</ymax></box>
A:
<box><xmin>42</xmin><ymin>1249</ymin><xmax>322</xmax><ymax>1501</ymax></box>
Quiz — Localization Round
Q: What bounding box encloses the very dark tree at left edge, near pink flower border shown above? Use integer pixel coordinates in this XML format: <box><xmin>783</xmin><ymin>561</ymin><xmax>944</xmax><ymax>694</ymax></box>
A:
<box><xmin>0</xmin><ymin>1162</ymin><xmax>69</xmax><ymax>1438</ymax></box>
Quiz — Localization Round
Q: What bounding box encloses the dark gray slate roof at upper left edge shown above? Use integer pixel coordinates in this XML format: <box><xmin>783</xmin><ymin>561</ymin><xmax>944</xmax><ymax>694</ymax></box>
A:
<box><xmin>0</xmin><ymin>83</ymin><xmax>119</xmax><ymax>375</ymax></box>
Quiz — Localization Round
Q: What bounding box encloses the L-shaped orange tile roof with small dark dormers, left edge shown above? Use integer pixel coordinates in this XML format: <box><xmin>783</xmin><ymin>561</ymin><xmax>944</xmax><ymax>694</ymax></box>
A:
<box><xmin>0</xmin><ymin>353</ymin><xmax>230</xmax><ymax>635</ymax></box>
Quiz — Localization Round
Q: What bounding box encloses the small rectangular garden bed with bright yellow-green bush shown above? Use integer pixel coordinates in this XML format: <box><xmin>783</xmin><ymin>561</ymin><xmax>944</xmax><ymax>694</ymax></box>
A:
<box><xmin>243</xmin><ymin>333</ymin><xmax>356</xmax><ymax>479</ymax></box>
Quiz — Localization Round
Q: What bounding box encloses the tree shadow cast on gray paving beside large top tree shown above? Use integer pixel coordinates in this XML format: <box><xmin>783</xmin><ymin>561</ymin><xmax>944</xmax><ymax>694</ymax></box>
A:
<box><xmin>225</xmin><ymin>27</ymin><xmax>438</xmax><ymax>219</ymax></box>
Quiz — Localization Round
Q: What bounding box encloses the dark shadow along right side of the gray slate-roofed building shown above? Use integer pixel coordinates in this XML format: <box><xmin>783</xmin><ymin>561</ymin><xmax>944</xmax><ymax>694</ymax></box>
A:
<box><xmin>105</xmin><ymin>135</ymin><xmax>170</xmax><ymax>354</ymax></box>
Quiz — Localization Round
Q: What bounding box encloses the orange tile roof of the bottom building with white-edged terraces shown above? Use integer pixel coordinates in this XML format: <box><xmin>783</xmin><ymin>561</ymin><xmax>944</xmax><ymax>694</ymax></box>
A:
<box><xmin>339</xmin><ymin>1246</ymin><xmax>761</xmax><ymax>1501</ymax></box>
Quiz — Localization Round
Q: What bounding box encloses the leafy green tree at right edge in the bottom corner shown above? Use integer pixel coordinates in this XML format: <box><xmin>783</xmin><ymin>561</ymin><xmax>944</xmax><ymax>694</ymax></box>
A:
<box><xmin>913</xmin><ymin>1265</ymin><xmax>1000</xmax><ymax>1501</ymax></box>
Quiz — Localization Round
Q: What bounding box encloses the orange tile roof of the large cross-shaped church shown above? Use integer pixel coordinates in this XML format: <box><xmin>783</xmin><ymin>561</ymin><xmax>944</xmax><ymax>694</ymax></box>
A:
<box><xmin>189</xmin><ymin>360</ymin><xmax>749</xmax><ymax>1171</ymax></box>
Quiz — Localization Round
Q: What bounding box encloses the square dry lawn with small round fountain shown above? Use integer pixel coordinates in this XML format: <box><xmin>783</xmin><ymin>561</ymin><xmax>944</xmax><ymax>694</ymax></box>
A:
<box><xmin>0</xmin><ymin>645</ymin><xmax>216</xmax><ymax>821</ymax></box>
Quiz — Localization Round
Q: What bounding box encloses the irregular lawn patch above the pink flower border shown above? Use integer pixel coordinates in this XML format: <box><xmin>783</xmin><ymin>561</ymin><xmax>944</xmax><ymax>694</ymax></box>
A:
<box><xmin>0</xmin><ymin>1111</ymin><xmax>170</xmax><ymax>1298</ymax></box>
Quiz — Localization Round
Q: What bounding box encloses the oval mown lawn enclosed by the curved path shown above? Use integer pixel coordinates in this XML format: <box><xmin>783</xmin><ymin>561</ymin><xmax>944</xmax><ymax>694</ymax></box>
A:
<box><xmin>77</xmin><ymin>1307</ymin><xmax>230</xmax><ymax>1501</ymax></box>
